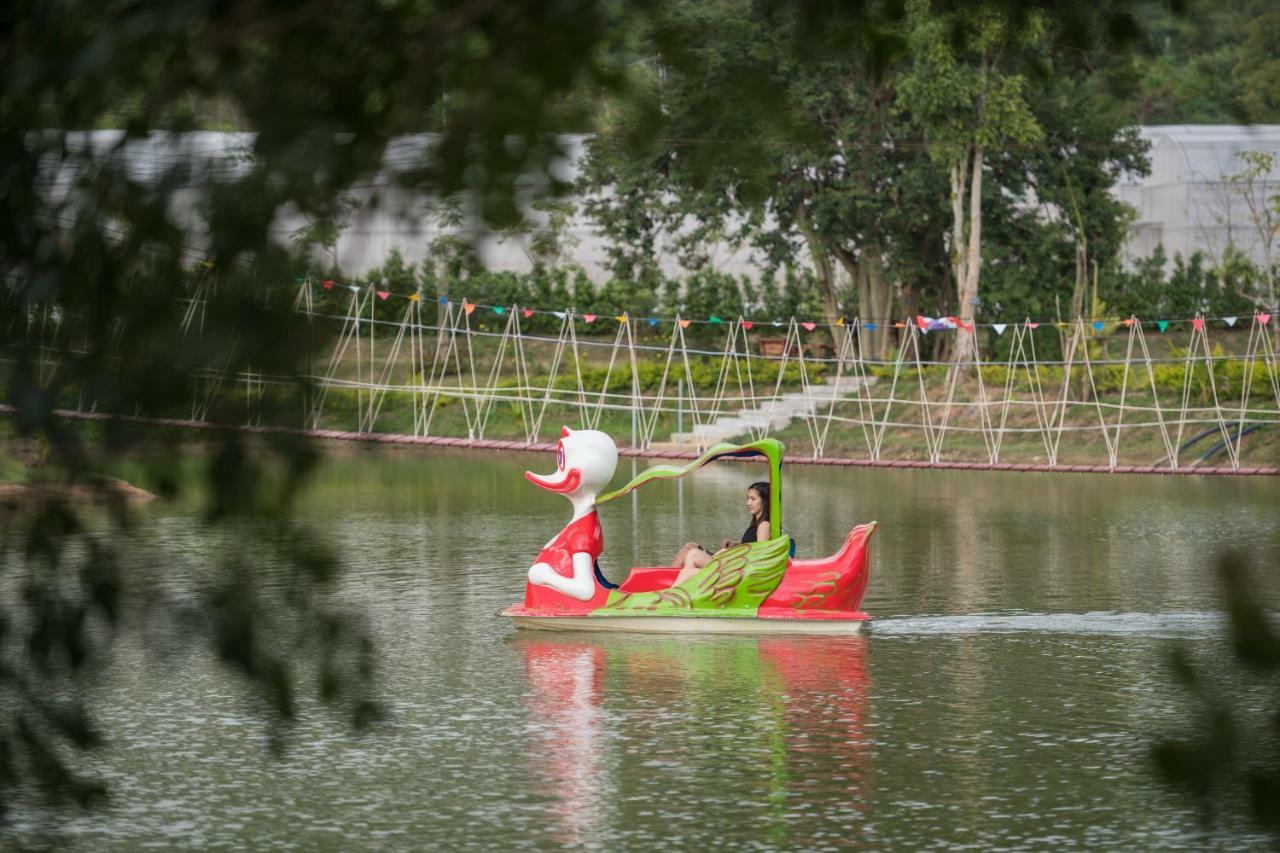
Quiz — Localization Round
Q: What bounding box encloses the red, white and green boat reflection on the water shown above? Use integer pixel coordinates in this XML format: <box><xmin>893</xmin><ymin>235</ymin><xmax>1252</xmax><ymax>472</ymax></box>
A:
<box><xmin>508</xmin><ymin>633</ymin><xmax>870</xmax><ymax>845</ymax></box>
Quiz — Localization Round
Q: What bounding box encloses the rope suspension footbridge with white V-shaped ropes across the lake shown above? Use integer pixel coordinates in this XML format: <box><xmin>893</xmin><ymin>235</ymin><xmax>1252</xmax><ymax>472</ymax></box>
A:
<box><xmin>10</xmin><ymin>286</ymin><xmax>1280</xmax><ymax>474</ymax></box>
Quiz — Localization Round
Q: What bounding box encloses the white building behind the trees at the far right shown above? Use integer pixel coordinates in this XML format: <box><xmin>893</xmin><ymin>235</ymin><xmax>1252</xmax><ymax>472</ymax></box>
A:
<box><xmin>1115</xmin><ymin>124</ymin><xmax>1280</xmax><ymax>263</ymax></box>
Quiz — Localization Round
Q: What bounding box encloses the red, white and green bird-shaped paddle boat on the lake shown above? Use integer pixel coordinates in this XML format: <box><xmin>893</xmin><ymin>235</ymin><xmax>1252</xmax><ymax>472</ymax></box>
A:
<box><xmin>503</xmin><ymin>427</ymin><xmax>876</xmax><ymax>634</ymax></box>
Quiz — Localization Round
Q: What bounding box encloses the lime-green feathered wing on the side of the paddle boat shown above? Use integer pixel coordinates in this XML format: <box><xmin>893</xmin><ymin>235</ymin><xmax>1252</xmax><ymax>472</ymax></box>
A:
<box><xmin>591</xmin><ymin>537</ymin><xmax>791</xmax><ymax>616</ymax></box>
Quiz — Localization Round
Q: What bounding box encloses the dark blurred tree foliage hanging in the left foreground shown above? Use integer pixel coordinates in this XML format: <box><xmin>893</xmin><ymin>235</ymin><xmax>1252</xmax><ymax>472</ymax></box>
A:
<box><xmin>0</xmin><ymin>0</ymin><xmax>629</xmax><ymax>812</ymax></box>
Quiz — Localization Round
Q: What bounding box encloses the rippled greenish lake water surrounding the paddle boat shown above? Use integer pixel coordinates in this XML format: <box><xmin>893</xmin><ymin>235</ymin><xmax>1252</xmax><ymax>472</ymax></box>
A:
<box><xmin>45</xmin><ymin>452</ymin><xmax>1280</xmax><ymax>850</ymax></box>
